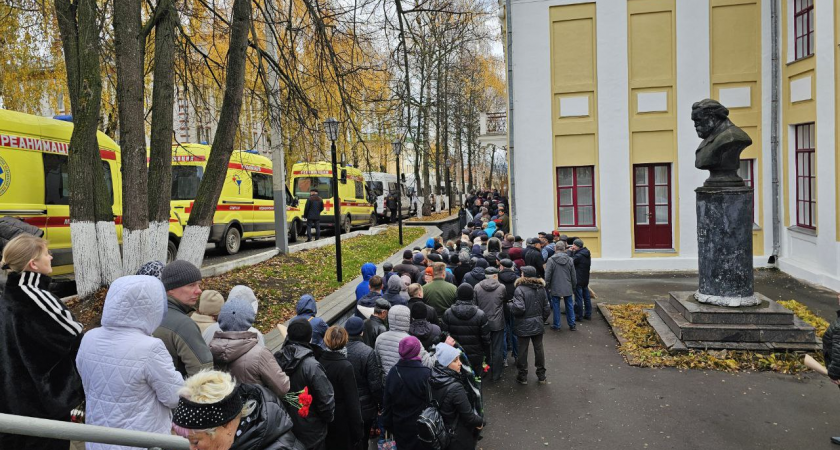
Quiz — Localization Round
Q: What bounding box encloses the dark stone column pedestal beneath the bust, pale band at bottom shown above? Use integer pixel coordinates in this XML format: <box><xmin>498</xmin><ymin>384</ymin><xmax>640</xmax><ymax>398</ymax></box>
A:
<box><xmin>695</xmin><ymin>186</ymin><xmax>760</xmax><ymax>307</ymax></box>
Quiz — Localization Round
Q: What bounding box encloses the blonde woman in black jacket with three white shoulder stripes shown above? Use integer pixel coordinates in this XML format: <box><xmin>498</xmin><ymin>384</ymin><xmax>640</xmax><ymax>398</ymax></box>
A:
<box><xmin>0</xmin><ymin>234</ymin><xmax>84</xmax><ymax>450</ymax></box>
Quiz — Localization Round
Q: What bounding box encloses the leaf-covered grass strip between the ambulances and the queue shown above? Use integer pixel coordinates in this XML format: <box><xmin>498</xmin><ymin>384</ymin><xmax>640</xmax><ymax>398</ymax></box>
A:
<box><xmin>203</xmin><ymin>227</ymin><xmax>425</xmax><ymax>332</ymax></box>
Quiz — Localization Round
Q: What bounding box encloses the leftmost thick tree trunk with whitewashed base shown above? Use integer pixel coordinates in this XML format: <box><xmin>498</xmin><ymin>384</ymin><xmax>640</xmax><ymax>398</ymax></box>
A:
<box><xmin>55</xmin><ymin>0</ymin><xmax>122</xmax><ymax>298</ymax></box>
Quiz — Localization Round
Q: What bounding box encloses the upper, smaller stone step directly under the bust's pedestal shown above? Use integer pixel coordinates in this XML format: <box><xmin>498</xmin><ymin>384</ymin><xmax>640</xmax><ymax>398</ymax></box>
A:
<box><xmin>668</xmin><ymin>291</ymin><xmax>794</xmax><ymax>325</ymax></box>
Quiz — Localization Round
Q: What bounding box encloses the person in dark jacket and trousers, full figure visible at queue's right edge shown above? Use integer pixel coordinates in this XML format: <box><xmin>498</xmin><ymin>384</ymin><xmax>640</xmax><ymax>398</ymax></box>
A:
<box><xmin>511</xmin><ymin>266</ymin><xmax>551</xmax><ymax>384</ymax></box>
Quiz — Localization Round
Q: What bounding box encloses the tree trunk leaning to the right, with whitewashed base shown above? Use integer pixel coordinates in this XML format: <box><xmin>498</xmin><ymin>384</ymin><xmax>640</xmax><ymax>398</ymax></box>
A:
<box><xmin>178</xmin><ymin>0</ymin><xmax>251</xmax><ymax>267</ymax></box>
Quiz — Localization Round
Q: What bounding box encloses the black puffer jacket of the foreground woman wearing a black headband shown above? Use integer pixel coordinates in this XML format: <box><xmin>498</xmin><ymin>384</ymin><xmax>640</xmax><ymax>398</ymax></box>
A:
<box><xmin>230</xmin><ymin>384</ymin><xmax>304</xmax><ymax>450</ymax></box>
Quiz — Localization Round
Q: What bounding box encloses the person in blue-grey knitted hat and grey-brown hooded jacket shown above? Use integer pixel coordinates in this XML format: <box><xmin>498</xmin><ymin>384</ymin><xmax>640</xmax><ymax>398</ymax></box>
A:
<box><xmin>204</xmin><ymin>298</ymin><xmax>289</xmax><ymax>397</ymax></box>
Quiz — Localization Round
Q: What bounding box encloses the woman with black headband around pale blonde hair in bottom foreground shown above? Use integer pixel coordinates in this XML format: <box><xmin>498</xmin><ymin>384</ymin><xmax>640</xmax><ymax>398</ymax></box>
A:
<box><xmin>172</xmin><ymin>370</ymin><xmax>301</xmax><ymax>450</ymax></box>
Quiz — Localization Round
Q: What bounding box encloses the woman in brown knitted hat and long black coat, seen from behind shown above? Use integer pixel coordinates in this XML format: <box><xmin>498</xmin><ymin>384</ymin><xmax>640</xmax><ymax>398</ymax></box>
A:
<box><xmin>319</xmin><ymin>326</ymin><xmax>364</xmax><ymax>450</ymax></box>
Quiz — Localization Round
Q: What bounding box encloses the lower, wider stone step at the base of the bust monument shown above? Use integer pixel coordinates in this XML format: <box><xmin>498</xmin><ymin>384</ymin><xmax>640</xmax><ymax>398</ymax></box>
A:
<box><xmin>654</xmin><ymin>300</ymin><xmax>816</xmax><ymax>343</ymax></box>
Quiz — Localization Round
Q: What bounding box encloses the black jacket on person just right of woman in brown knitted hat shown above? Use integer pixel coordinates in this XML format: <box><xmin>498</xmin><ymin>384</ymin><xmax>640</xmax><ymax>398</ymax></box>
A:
<box><xmin>347</xmin><ymin>336</ymin><xmax>383</xmax><ymax>420</ymax></box>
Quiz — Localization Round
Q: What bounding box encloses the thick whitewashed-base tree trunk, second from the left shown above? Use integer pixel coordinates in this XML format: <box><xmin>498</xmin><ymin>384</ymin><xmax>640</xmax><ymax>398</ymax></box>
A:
<box><xmin>113</xmin><ymin>0</ymin><xmax>149</xmax><ymax>273</ymax></box>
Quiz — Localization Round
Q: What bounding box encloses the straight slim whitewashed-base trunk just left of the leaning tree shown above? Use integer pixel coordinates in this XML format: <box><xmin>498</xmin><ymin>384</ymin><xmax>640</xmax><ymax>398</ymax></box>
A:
<box><xmin>146</xmin><ymin>0</ymin><xmax>178</xmax><ymax>262</ymax></box>
